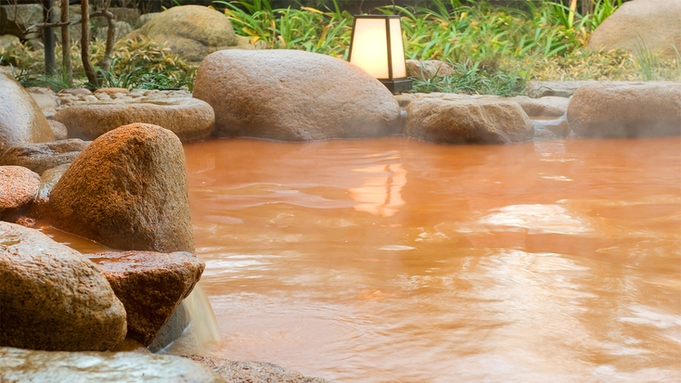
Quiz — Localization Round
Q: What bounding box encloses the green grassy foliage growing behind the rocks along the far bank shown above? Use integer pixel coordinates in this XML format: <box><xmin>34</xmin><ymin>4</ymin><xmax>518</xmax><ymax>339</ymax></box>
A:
<box><xmin>0</xmin><ymin>0</ymin><xmax>681</xmax><ymax>95</ymax></box>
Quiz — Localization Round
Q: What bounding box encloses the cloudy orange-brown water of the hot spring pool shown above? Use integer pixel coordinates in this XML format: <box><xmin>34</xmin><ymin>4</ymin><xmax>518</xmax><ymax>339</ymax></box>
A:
<box><xmin>185</xmin><ymin>137</ymin><xmax>681</xmax><ymax>382</ymax></box>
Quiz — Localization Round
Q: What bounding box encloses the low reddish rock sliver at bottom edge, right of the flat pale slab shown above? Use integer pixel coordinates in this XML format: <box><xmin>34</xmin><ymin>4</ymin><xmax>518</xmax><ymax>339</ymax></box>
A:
<box><xmin>184</xmin><ymin>355</ymin><xmax>329</xmax><ymax>383</ymax></box>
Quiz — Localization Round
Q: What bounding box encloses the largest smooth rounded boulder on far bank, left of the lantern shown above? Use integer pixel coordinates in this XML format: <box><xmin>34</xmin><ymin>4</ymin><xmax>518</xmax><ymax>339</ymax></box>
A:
<box><xmin>194</xmin><ymin>50</ymin><xmax>402</xmax><ymax>141</ymax></box>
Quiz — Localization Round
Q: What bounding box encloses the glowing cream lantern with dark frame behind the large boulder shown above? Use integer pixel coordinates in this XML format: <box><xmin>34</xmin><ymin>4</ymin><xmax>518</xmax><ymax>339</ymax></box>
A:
<box><xmin>350</xmin><ymin>15</ymin><xmax>411</xmax><ymax>93</ymax></box>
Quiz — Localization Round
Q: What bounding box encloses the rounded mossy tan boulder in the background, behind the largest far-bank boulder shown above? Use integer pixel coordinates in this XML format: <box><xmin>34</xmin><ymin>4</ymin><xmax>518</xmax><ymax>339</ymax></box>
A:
<box><xmin>126</xmin><ymin>5</ymin><xmax>237</xmax><ymax>63</ymax></box>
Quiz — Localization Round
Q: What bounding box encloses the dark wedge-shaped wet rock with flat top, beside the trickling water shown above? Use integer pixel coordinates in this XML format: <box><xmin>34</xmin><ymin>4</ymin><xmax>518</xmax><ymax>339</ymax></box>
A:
<box><xmin>87</xmin><ymin>251</ymin><xmax>205</xmax><ymax>346</ymax></box>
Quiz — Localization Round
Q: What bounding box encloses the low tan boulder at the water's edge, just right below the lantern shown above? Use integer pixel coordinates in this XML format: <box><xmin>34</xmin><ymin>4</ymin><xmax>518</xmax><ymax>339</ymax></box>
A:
<box><xmin>405</xmin><ymin>98</ymin><xmax>534</xmax><ymax>144</ymax></box>
